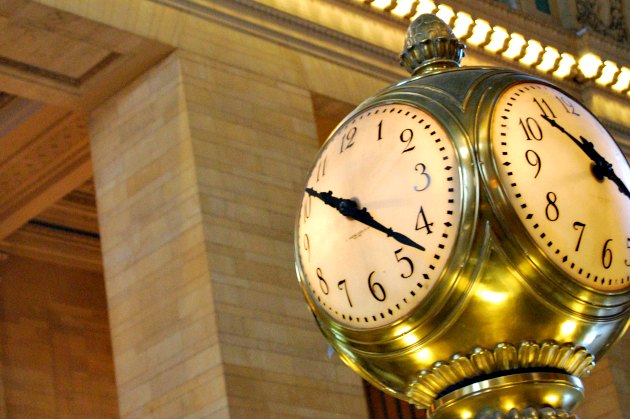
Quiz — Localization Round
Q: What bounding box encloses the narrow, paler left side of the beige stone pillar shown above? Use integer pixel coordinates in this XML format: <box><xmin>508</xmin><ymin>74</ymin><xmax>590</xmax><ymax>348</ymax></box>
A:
<box><xmin>90</xmin><ymin>55</ymin><xmax>228</xmax><ymax>418</ymax></box>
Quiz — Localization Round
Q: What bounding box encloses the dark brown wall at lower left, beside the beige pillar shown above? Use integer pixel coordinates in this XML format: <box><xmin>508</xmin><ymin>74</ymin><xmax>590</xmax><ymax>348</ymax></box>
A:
<box><xmin>0</xmin><ymin>255</ymin><xmax>118</xmax><ymax>418</ymax></box>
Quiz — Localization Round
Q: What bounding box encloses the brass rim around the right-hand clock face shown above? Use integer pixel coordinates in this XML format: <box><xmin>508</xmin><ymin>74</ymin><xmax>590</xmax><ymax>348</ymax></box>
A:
<box><xmin>475</xmin><ymin>78</ymin><xmax>630</xmax><ymax>302</ymax></box>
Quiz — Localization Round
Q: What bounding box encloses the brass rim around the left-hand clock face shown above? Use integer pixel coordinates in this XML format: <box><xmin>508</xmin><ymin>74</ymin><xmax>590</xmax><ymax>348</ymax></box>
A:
<box><xmin>295</xmin><ymin>92</ymin><xmax>478</xmax><ymax>341</ymax></box>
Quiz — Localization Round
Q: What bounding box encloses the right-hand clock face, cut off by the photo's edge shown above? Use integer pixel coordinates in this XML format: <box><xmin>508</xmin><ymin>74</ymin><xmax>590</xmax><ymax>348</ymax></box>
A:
<box><xmin>491</xmin><ymin>83</ymin><xmax>630</xmax><ymax>291</ymax></box>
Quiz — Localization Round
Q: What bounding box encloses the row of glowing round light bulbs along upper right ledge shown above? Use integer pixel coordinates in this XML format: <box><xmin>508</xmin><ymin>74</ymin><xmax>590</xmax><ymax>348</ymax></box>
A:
<box><xmin>358</xmin><ymin>0</ymin><xmax>630</xmax><ymax>95</ymax></box>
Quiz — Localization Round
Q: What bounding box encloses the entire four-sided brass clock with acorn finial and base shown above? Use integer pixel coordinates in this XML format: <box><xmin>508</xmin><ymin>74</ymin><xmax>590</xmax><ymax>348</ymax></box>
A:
<box><xmin>295</xmin><ymin>15</ymin><xmax>630</xmax><ymax>419</ymax></box>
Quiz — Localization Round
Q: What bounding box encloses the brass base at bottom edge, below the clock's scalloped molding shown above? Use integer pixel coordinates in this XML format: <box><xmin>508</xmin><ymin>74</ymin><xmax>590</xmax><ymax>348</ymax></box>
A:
<box><xmin>428</xmin><ymin>372</ymin><xmax>584</xmax><ymax>419</ymax></box>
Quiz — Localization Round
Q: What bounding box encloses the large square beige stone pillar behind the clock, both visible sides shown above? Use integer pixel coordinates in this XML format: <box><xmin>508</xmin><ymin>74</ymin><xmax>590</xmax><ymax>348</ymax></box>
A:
<box><xmin>90</xmin><ymin>46</ymin><xmax>367</xmax><ymax>418</ymax></box>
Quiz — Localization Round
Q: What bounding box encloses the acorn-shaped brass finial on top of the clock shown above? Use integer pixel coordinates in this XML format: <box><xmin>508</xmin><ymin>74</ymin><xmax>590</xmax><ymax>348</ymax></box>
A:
<box><xmin>400</xmin><ymin>14</ymin><xmax>466</xmax><ymax>75</ymax></box>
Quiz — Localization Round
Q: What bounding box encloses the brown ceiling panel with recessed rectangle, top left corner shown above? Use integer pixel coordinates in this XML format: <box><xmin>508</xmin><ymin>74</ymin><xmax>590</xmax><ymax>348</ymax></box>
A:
<box><xmin>0</xmin><ymin>0</ymin><xmax>172</xmax><ymax>111</ymax></box>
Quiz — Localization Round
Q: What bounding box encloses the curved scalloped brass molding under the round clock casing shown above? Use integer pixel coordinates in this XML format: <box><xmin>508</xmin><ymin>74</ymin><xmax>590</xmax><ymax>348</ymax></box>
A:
<box><xmin>406</xmin><ymin>341</ymin><xmax>595</xmax><ymax>406</ymax></box>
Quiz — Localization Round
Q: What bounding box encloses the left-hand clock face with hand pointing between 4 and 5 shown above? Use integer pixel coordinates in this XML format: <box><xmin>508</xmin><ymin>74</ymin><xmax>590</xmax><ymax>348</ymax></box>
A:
<box><xmin>296</xmin><ymin>104</ymin><xmax>461</xmax><ymax>329</ymax></box>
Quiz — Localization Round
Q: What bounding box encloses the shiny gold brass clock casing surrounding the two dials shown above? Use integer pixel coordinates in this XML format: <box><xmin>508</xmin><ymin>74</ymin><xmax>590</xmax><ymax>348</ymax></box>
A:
<box><xmin>296</xmin><ymin>68</ymin><xmax>630</xmax><ymax>417</ymax></box>
